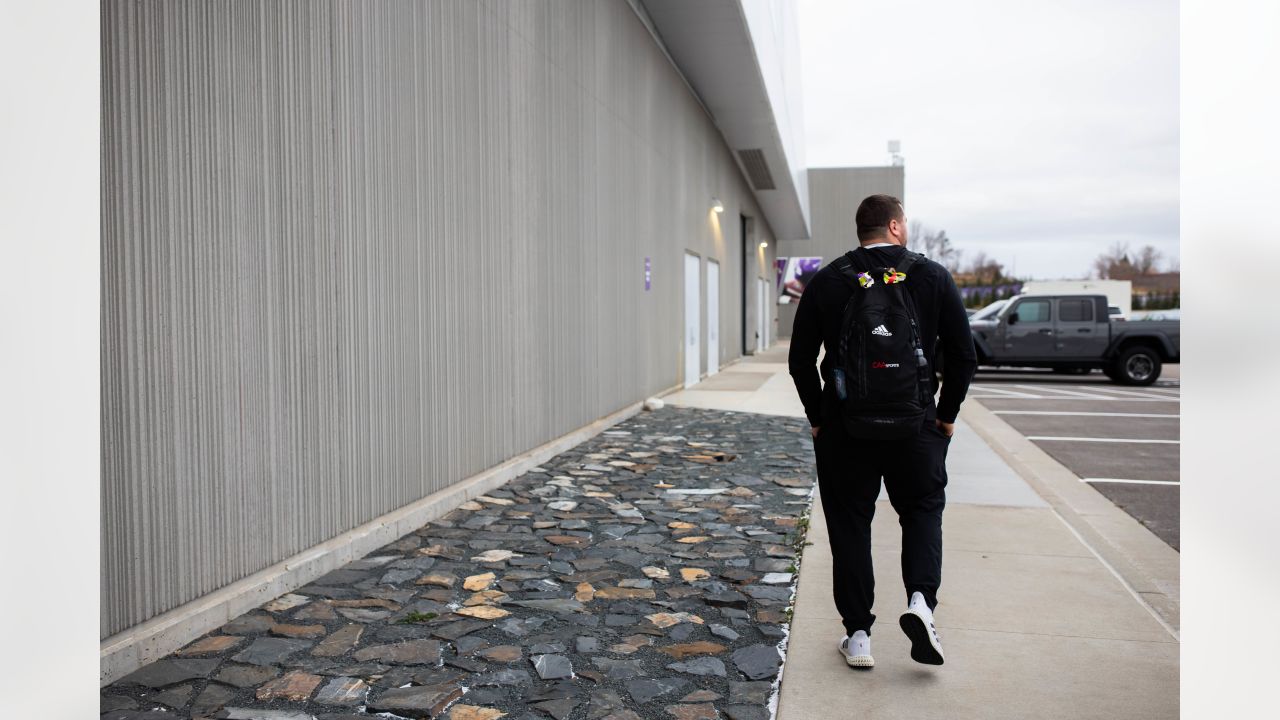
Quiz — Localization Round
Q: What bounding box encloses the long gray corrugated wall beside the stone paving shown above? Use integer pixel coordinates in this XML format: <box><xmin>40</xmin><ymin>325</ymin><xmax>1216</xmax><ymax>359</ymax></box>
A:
<box><xmin>101</xmin><ymin>0</ymin><xmax>773</xmax><ymax>637</ymax></box>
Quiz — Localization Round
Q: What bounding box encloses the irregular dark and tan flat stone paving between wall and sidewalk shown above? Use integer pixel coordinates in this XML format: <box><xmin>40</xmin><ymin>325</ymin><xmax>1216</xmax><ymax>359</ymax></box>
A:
<box><xmin>101</xmin><ymin>406</ymin><xmax>814</xmax><ymax>720</ymax></box>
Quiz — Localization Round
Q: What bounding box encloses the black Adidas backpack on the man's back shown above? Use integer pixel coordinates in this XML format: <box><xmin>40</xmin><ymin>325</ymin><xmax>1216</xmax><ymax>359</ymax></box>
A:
<box><xmin>828</xmin><ymin>250</ymin><xmax>932</xmax><ymax>438</ymax></box>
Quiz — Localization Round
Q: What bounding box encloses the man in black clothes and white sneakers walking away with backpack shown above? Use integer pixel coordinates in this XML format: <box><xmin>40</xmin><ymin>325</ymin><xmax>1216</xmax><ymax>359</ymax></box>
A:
<box><xmin>788</xmin><ymin>195</ymin><xmax>978</xmax><ymax>667</ymax></box>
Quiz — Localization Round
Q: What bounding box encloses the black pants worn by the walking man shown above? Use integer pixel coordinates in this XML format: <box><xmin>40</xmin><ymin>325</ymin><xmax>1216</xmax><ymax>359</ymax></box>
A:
<box><xmin>813</xmin><ymin>419</ymin><xmax>951</xmax><ymax>635</ymax></box>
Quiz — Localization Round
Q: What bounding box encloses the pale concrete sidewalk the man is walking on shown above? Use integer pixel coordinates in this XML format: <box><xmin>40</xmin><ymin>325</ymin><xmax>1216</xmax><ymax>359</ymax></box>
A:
<box><xmin>667</xmin><ymin>345</ymin><xmax>1179</xmax><ymax>720</ymax></box>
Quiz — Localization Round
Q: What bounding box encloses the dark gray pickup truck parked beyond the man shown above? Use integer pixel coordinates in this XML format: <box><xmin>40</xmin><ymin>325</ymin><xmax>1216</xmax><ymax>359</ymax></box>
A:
<box><xmin>969</xmin><ymin>295</ymin><xmax>1180</xmax><ymax>386</ymax></box>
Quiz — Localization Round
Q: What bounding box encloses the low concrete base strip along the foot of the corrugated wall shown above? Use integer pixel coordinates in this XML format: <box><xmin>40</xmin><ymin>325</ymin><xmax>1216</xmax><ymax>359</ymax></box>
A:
<box><xmin>99</xmin><ymin>388</ymin><xmax>677</xmax><ymax>685</ymax></box>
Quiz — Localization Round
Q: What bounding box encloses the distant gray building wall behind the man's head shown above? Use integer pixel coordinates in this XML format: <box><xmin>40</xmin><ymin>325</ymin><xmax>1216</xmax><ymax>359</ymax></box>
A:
<box><xmin>774</xmin><ymin>165</ymin><xmax>910</xmax><ymax>337</ymax></box>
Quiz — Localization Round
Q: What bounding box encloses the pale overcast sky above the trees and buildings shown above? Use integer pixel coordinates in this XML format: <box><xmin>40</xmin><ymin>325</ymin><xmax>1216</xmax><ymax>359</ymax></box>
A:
<box><xmin>797</xmin><ymin>0</ymin><xmax>1177</xmax><ymax>279</ymax></box>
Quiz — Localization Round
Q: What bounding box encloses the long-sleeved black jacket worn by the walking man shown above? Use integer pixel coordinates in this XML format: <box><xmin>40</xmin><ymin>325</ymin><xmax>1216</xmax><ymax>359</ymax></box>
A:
<box><xmin>787</xmin><ymin>245</ymin><xmax>978</xmax><ymax>427</ymax></box>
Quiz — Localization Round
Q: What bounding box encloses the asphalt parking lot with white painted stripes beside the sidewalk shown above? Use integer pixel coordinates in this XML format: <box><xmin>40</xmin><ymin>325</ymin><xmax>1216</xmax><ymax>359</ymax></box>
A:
<box><xmin>969</xmin><ymin>365</ymin><xmax>1181</xmax><ymax>550</ymax></box>
